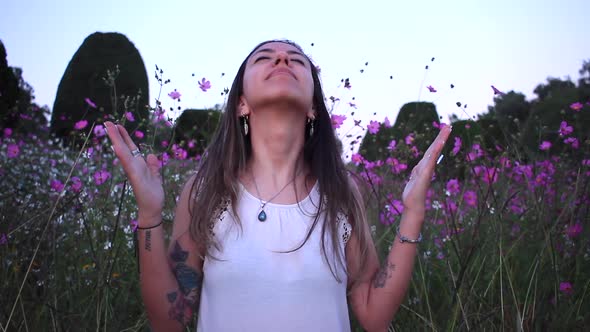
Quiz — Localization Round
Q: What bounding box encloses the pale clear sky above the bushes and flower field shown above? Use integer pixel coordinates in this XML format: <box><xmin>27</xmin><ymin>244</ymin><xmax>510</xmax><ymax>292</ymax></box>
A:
<box><xmin>0</xmin><ymin>0</ymin><xmax>590</xmax><ymax>130</ymax></box>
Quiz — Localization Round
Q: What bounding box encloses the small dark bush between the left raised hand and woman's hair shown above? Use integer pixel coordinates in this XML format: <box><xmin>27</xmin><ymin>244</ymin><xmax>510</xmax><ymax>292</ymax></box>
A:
<box><xmin>174</xmin><ymin>108</ymin><xmax>221</xmax><ymax>156</ymax></box>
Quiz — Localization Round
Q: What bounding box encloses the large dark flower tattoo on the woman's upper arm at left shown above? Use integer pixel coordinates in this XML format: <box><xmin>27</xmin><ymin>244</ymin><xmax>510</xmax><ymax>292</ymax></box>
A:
<box><xmin>167</xmin><ymin>241</ymin><xmax>203</xmax><ymax>326</ymax></box>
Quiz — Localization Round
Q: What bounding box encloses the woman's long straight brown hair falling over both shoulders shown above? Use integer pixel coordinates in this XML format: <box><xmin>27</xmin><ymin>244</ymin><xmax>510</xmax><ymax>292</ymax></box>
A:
<box><xmin>189</xmin><ymin>40</ymin><xmax>372</xmax><ymax>281</ymax></box>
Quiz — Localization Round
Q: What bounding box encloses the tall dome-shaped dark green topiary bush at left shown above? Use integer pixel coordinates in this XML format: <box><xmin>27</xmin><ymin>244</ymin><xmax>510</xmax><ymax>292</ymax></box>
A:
<box><xmin>51</xmin><ymin>32</ymin><xmax>149</xmax><ymax>141</ymax></box>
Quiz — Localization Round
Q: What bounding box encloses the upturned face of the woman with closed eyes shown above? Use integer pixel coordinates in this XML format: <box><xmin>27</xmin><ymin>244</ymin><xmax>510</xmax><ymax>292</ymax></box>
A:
<box><xmin>241</xmin><ymin>42</ymin><xmax>314</xmax><ymax>112</ymax></box>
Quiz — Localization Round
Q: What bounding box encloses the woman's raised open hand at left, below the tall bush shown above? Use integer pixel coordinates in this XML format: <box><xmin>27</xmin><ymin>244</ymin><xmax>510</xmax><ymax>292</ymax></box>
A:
<box><xmin>105</xmin><ymin>121</ymin><xmax>164</xmax><ymax>222</ymax></box>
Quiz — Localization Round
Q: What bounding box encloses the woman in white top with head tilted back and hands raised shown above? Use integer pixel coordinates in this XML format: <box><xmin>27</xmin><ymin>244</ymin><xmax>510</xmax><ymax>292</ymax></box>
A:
<box><xmin>106</xmin><ymin>41</ymin><xmax>450</xmax><ymax>331</ymax></box>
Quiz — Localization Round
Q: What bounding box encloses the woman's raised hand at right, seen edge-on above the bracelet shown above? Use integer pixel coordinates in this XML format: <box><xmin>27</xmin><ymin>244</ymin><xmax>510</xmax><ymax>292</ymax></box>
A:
<box><xmin>402</xmin><ymin>125</ymin><xmax>451</xmax><ymax>215</ymax></box>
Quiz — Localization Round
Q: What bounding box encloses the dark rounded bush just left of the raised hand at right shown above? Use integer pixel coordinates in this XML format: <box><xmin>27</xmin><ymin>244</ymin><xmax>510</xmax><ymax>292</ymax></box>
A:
<box><xmin>359</xmin><ymin>102</ymin><xmax>439</xmax><ymax>160</ymax></box>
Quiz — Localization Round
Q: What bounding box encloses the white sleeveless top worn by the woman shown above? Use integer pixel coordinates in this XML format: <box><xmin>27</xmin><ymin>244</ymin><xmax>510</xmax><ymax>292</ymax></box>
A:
<box><xmin>197</xmin><ymin>182</ymin><xmax>351</xmax><ymax>332</ymax></box>
